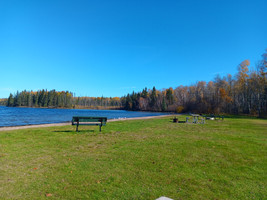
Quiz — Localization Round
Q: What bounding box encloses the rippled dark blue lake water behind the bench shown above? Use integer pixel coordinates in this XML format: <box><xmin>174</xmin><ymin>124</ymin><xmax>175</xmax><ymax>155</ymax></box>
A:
<box><xmin>0</xmin><ymin>106</ymin><xmax>169</xmax><ymax>127</ymax></box>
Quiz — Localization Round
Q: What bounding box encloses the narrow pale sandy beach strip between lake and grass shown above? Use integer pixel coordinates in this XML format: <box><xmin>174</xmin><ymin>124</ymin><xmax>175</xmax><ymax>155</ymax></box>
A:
<box><xmin>0</xmin><ymin>115</ymin><xmax>172</xmax><ymax>132</ymax></box>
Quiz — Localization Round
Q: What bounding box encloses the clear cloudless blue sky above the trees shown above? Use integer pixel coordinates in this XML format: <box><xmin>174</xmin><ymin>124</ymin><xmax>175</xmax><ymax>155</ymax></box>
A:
<box><xmin>0</xmin><ymin>0</ymin><xmax>267</xmax><ymax>98</ymax></box>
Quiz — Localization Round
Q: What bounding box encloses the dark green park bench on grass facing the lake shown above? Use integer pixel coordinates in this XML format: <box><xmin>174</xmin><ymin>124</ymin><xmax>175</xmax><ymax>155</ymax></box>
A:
<box><xmin>72</xmin><ymin>116</ymin><xmax>107</xmax><ymax>132</ymax></box>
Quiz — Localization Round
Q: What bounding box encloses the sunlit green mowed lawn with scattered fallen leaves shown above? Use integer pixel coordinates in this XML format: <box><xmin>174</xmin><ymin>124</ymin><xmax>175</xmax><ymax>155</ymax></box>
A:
<box><xmin>0</xmin><ymin>116</ymin><xmax>267</xmax><ymax>199</ymax></box>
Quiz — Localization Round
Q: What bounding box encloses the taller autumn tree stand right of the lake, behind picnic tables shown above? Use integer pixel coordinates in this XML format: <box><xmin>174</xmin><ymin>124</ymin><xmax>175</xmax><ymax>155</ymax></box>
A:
<box><xmin>121</xmin><ymin>50</ymin><xmax>267</xmax><ymax>116</ymax></box>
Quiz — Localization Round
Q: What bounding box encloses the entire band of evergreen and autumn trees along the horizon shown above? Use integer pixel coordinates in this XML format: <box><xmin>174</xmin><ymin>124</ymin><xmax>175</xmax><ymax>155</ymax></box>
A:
<box><xmin>3</xmin><ymin>50</ymin><xmax>267</xmax><ymax>116</ymax></box>
